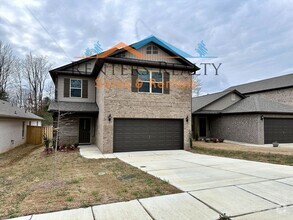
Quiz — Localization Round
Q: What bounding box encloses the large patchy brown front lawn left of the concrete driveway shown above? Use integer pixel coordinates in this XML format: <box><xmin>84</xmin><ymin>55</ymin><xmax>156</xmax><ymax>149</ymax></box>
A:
<box><xmin>0</xmin><ymin>146</ymin><xmax>180</xmax><ymax>218</ymax></box>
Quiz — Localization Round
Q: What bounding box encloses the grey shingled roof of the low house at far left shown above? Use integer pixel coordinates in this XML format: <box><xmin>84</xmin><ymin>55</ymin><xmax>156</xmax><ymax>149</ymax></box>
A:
<box><xmin>0</xmin><ymin>100</ymin><xmax>44</xmax><ymax>120</ymax></box>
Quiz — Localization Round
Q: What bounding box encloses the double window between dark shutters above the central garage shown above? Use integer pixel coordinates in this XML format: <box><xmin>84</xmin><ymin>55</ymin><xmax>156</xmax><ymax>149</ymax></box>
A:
<box><xmin>138</xmin><ymin>70</ymin><xmax>163</xmax><ymax>93</ymax></box>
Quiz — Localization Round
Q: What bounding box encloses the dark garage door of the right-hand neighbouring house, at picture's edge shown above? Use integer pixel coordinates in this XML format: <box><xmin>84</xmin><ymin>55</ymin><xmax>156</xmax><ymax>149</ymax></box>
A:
<box><xmin>264</xmin><ymin>118</ymin><xmax>293</xmax><ymax>144</ymax></box>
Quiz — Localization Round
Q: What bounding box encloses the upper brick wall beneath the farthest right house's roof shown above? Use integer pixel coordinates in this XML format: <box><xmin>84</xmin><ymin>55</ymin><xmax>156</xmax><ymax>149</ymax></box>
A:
<box><xmin>247</xmin><ymin>88</ymin><xmax>293</xmax><ymax>105</ymax></box>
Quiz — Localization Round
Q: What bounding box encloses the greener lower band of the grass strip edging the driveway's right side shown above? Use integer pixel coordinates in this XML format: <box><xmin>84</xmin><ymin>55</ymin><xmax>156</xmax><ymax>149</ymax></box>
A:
<box><xmin>190</xmin><ymin>144</ymin><xmax>293</xmax><ymax>166</ymax></box>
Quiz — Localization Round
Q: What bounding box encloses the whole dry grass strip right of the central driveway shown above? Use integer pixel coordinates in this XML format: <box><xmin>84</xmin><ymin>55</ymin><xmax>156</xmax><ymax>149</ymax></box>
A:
<box><xmin>190</xmin><ymin>141</ymin><xmax>293</xmax><ymax>166</ymax></box>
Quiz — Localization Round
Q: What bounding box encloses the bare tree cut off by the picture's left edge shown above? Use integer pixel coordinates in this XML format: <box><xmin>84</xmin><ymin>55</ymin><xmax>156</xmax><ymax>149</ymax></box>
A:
<box><xmin>0</xmin><ymin>40</ymin><xmax>15</xmax><ymax>100</ymax></box>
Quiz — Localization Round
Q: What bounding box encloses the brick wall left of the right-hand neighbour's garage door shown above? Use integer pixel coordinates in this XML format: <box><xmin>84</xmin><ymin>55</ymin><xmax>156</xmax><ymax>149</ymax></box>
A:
<box><xmin>210</xmin><ymin>114</ymin><xmax>264</xmax><ymax>144</ymax></box>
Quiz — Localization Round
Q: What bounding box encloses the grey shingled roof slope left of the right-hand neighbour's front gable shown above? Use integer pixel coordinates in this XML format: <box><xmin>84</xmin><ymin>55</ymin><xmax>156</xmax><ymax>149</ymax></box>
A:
<box><xmin>192</xmin><ymin>90</ymin><xmax>245</xmax><ymax>113</ymax></box>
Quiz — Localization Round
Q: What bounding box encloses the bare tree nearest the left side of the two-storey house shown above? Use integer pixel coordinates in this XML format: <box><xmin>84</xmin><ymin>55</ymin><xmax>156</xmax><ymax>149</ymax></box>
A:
<box><xmin>22</xmin><ymin>53</ymin><xmax>52</xmax><ymax>113</ymax></box>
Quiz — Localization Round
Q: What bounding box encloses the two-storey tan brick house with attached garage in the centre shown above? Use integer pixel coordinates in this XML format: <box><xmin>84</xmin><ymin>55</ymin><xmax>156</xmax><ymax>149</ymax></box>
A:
<box><xmin>49</xmin><ymin>36</ymin><xmax>199</xmax><ymax>153</ymax></box>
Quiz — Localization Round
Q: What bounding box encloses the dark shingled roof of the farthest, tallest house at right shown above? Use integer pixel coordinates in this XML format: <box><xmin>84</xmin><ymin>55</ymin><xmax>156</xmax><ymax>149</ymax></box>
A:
<box><xmin>225</xmin><ymin>73</ymin><xmax>293</xmax><ymax>94</ymax></box>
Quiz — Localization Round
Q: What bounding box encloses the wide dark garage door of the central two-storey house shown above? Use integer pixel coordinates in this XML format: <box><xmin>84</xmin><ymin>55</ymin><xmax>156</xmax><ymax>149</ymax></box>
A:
<box><xmin>114</xmin><ymin>119</ymin><xmax>183</xmax><ymax>152</ymax></box>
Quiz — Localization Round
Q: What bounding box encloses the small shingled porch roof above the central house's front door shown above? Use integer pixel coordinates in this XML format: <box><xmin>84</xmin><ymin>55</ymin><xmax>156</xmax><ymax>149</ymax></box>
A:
<box><xmin>48</xmin><ymin>102</ymin><xmax>99</xmax><ymax>112</ymax></box>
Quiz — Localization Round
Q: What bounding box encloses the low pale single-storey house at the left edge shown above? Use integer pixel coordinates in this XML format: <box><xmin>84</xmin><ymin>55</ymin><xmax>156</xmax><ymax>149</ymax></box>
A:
<box><xmin>0</xmin><ymin>100</ymin><xmax>43</xmax><ymax>153</ymax></box>
